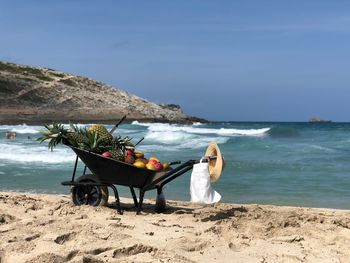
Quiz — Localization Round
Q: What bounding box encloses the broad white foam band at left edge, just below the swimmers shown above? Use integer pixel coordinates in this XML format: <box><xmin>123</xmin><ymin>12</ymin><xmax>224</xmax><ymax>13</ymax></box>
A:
<box><xmin>0</xmin><ymin>143</ymin><xmax>74</xmax><ymax>164</ymax></box>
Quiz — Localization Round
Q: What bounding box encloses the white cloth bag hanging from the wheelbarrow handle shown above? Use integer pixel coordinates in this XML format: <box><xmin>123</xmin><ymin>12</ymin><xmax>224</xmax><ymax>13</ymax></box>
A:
<box><xmin>190</xmin><ymin>159</ymin><xmax>221</xmax><ymax>204</ymax></box>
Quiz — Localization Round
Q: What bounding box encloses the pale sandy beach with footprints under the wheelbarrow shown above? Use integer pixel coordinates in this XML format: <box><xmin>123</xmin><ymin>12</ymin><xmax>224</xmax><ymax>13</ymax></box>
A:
<box><xmin>0</xmin><ymin>192</ymin><xmax>350</xmax><ymax>263</ymax></box>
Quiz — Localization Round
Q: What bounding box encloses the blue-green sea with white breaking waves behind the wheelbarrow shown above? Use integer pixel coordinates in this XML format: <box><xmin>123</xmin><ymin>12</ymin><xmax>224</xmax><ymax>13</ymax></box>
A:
<box><xmin>0</xmin><ymin>121</ymin><xmax>350</xmax><ymax>209</ymax></box>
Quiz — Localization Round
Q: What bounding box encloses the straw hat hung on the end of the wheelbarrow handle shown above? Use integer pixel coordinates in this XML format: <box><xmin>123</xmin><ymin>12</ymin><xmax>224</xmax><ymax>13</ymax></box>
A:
<box><xmin>205</xmin><ymin>142</ymin><xmax>225</xmax><ymax>182</ymax></box>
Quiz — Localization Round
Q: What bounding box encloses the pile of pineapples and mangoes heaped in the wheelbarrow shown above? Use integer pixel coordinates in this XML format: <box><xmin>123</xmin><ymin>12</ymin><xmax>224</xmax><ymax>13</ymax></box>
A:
<box><xmin>38</xmin><ymin>123</ymin><xmax>170</xmax><ymax>171</ymax></box>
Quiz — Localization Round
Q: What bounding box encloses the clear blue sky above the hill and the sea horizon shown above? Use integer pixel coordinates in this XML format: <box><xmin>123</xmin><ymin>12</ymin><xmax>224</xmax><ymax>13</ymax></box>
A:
<box><xmin>0</xmin><ymin>0</ymin><xmax>350</xmax><ymax>121</ymax></box>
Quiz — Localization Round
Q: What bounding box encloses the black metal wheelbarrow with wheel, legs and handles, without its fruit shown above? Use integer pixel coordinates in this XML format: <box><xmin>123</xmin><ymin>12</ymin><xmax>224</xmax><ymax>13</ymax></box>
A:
<box><xmin>62</xmin><ymin>146</ymin><xmax>198</xmax><ymax>214</ymax></box>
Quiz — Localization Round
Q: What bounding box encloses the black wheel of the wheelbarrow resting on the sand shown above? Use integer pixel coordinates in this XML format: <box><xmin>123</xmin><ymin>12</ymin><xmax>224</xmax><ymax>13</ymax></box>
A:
<box><xmin>72</xmin><ymin>174</ymin><xmax>108</xmax><ymax>206</ymax></box>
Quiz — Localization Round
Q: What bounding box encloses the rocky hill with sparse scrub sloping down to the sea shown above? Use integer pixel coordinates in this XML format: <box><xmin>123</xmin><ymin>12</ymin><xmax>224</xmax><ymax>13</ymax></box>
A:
<box><xmin>0</xmin><ymin>62</ymin><xmax>203</xmax><ymax>124</ymax></box>
